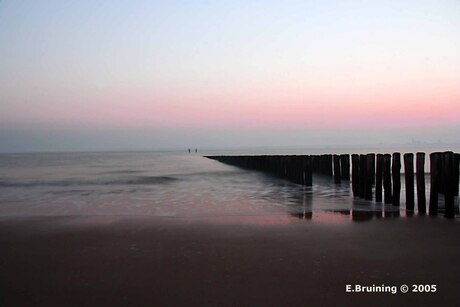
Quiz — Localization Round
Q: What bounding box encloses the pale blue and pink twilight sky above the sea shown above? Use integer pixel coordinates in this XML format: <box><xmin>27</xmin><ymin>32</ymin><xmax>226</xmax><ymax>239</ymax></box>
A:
<box><xmin>0</xmin><ymin>0</ymin><xmax>460</xmax><ymax>152</ymax></box>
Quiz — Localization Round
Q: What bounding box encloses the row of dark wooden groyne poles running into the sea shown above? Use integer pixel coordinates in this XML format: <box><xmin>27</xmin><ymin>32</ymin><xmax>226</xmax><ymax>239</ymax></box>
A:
<box><xmin>207</xmin><ymin>151</ymin><xmax>460</xmax><ymax>218</ymax></box>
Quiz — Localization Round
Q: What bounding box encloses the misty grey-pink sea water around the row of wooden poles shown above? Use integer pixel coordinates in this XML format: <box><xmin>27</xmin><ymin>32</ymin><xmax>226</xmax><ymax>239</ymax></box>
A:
<box><xmin>0</xmin><ymin>148</ymin><xmax>458</xmax><ymax>221</ymax></box>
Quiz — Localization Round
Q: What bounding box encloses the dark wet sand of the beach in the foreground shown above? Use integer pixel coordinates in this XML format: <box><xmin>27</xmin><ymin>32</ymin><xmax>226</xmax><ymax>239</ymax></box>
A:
<box><xmin>0</xmin><ymin>217</ymin><xmax>460</xmax><ymax>306</ymax></box>
